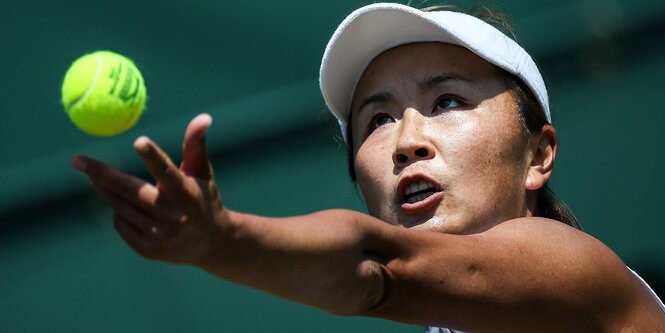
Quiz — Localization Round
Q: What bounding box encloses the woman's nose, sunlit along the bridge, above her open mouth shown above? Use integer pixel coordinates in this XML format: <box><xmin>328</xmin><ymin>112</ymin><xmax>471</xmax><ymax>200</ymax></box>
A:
<box><xmin>393</xmin><ymin>109</ymin><xmax>435</xmax><ymax>168</ymax></box>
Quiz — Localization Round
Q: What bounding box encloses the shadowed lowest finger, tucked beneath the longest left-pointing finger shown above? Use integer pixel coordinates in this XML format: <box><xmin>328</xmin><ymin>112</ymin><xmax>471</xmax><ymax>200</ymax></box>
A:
<box><xmin>99</xmin><ymin>189</ymin><xmax>164</xmax><ymax>238</ymax></box>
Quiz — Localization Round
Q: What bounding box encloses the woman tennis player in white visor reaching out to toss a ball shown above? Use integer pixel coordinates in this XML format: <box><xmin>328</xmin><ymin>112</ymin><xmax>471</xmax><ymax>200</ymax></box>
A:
<box><xmin>73</xmin><ymin>4</ymin><xmax>665</xmax><ymax>332</ymax></box>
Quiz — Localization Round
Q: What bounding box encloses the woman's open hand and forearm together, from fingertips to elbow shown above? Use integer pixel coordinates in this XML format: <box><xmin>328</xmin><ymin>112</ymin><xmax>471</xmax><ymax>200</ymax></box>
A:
<box><xmin>73</xmin><ymin>115</ymin><xmax>388</xmax><ymax>314</ymax></box>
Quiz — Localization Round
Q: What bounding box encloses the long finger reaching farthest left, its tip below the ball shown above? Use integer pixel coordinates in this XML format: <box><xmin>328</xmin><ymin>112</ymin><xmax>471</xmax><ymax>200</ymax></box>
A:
<box><xmin>72</xmin><ymin>155</ymin><xmax>159</xmax><ymax>209</ymax></box>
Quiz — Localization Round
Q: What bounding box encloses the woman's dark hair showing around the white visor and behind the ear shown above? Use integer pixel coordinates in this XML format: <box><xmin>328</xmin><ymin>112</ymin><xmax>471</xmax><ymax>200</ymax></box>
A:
<box><xmin>346</xmin><ymin>5</ymin><xmax>582</xmax><ymax>230</ymax></box>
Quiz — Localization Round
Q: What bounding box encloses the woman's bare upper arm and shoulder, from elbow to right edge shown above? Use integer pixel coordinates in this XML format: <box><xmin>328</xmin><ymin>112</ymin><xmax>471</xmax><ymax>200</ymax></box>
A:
<box><xmin>368</xmin><ymin>218</ymin><xmax>663</xmax><ymax>332</ymax></box>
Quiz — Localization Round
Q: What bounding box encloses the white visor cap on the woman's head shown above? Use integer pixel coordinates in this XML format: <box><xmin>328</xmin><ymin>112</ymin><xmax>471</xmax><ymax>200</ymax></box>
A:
<box><xmin>319</xmin><ymin>3</ymin><xmax>552</xmax><ymax>140</ymax></box>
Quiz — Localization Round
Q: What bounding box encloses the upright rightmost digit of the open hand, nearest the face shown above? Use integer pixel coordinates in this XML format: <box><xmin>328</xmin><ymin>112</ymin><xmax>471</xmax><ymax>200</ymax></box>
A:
<box><xmin>182</xmin><ymin>113</ymin><xmax>212</xmax><ymax>180</ymax></box>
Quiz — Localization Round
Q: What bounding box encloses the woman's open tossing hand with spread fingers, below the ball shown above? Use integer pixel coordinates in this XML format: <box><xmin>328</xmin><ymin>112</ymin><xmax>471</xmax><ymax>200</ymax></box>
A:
<box><xmin>72</xmin><ymin>114</ymin><xmax>228</xmax><ymax>265</ymax></box>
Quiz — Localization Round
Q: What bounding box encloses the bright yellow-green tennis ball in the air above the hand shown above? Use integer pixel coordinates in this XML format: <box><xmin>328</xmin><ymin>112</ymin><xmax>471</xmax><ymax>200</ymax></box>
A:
<box><xmin>62</xmin><ymin>51</ymin><xmax>146</xmax><ymax>137</ymax></box>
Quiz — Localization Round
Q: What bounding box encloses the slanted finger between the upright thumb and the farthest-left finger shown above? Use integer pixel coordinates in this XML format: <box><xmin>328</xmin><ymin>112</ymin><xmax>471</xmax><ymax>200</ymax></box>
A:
<box><xmin>134</xmin><ymin>136</ymin><xmax>183</xmax><ymax>193</ymax></box>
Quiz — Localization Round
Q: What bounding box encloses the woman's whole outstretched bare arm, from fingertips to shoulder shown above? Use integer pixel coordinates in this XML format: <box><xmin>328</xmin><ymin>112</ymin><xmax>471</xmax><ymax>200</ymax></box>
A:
<box><xmin>73</xmin><ymin>115</ymin><xmax>665</xmax><ymax>332</ymax></box>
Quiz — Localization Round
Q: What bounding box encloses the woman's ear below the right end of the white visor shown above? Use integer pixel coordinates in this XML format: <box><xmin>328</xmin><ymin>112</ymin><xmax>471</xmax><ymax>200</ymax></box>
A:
<box><xmin>524</xmin><ymin>124</ymin><xmax>557</xmax><ymax>191</ymax></box>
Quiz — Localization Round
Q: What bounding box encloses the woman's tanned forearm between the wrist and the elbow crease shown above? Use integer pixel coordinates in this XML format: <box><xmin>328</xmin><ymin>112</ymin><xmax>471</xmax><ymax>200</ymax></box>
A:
<box><xmin>200</xmin><ymin>210</ymin><xmax>392</xmax><ymax>314</ymax></box>
